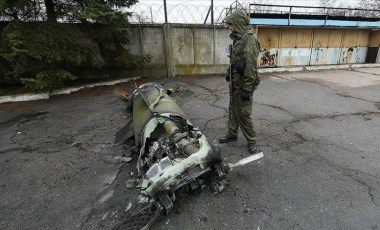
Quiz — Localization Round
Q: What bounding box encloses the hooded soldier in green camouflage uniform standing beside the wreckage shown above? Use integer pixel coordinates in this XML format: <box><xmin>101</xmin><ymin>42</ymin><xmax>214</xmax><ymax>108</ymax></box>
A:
<box><xmin>219</xmin><ymin>11</ymin><xmax>260</xmax><ymax>154</ymax></box>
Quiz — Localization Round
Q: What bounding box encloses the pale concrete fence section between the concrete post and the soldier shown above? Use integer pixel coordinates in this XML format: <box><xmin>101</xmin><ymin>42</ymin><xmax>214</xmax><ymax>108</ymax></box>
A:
<box><xmin>169</xmin><ymin>25</ymin><xmax>232</xmax><ymax>76</ymax></box>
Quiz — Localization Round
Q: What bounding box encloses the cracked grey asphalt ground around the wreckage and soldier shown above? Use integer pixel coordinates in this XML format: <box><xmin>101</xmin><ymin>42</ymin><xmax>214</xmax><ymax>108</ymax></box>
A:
<box><xmin>0</xmin><ymin>68</ymin><xmax>380</xmax><ymax>230</ymax></box>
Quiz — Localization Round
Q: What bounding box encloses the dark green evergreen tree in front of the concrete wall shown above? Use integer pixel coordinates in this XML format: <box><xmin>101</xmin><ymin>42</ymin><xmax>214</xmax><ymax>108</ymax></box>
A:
<box><xmin>0</xmin><ymin>0</ymin><xmax>148</xmax><ymax>91</ymax></box>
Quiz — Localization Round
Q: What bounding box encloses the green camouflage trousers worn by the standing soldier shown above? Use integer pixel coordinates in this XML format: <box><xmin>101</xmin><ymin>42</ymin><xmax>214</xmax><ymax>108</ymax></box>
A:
<box><xmin>227</xmin><ymin>91</ymin><xmax>256</xmax><ymax>143</ymax></box>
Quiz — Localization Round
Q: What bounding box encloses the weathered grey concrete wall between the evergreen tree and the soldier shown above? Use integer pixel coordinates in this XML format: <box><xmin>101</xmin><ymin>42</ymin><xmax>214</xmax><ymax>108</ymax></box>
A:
<box><xmin>126</xmin><ymin>24</ymin><xmax>231</xmax><ymax>77</ymax></box>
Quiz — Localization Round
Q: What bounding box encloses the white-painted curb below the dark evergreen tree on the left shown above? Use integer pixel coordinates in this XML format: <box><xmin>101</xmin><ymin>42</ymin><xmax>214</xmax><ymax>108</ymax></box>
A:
<box><xmin>0</xmin><ymin>77</ymin><xmax>140</xmax><ymax>104</ymax></box>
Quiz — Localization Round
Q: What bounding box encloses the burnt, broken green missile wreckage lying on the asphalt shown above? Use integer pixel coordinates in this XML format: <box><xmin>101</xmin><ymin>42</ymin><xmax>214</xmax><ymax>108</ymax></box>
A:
<box><xmin>114</xmin><ymin>83</ymin><xmax>263</xmax><ymax>229</ymax></box>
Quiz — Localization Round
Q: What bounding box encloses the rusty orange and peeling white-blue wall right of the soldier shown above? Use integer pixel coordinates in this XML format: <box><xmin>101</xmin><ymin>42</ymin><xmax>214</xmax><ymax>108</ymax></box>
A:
<box><xmin>258</xmin><ymin>27</ymin><xmax>375</xmax><ymax>67</ymax></box>
